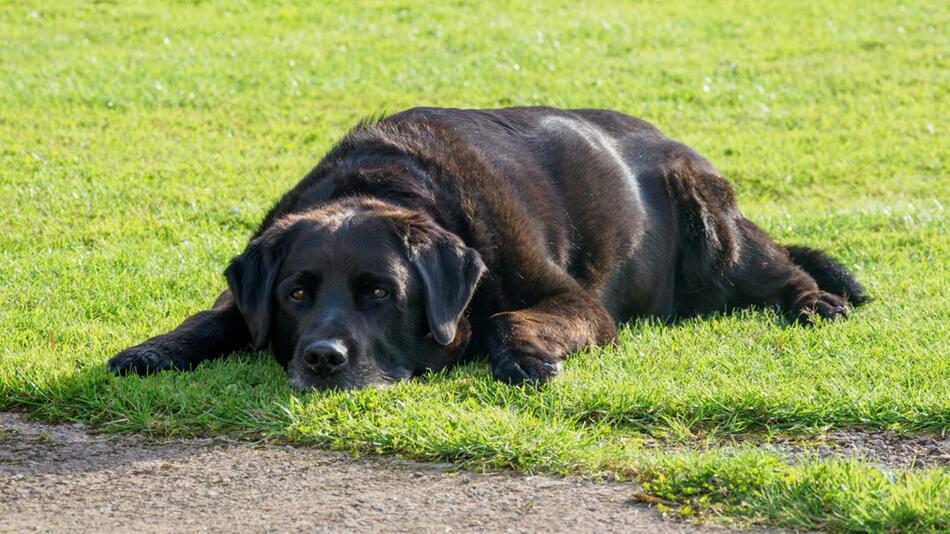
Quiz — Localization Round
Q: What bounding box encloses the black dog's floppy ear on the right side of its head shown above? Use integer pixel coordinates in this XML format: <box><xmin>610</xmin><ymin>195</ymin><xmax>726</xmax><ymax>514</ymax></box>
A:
<box><xmin>410</xmin><ymin>231</ymin><xmax>486</xmax><ymax>345</ymax></box>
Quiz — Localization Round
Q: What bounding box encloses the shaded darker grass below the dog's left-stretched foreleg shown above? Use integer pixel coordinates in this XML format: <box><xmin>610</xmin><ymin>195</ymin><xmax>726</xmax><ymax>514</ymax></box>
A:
<box><xmin>4</xmin><ymin>353</ymin><xmax>292</xmax><ymax>438</ymax></box>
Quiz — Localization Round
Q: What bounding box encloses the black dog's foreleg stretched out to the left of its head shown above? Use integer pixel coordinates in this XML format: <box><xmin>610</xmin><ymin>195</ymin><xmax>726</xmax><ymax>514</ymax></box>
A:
<box><xmin>106</xmin><ymin>291</ymin><xmax>251</xmax><ymax>375</ymax></box>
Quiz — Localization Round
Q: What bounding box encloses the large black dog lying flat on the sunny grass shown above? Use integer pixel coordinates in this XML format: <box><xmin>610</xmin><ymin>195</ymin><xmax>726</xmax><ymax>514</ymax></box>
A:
<box><xmin>108</xmin><ymin>108</ymin><xmax>867</xmax><ymax>388</ymax></box>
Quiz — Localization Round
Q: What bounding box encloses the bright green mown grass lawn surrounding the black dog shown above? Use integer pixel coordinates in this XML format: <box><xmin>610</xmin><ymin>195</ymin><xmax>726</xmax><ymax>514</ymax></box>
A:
<box><xmin>0</xmin><ymin>0</ymin><xmax>950</xmax><ymax>532</ymax></box>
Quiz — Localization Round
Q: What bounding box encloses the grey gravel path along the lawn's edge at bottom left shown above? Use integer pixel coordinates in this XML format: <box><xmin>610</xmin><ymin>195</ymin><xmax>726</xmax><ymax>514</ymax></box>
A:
<box><xmin>0</xmin><ymin>413</ymin><xmax>723</xmax><ymax>534</ymax></box>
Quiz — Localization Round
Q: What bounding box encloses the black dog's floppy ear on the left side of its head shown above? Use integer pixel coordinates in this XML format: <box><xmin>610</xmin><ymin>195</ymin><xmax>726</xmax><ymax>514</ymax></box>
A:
<box><xmin>224</xmin><ymin>226</ymin><xmax>286</xmax><ymax>350</ymax></box>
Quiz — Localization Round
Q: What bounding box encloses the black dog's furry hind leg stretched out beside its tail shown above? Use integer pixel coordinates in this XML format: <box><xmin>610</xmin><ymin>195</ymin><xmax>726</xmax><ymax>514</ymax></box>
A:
<box><xmin>663</xmin><ymin>153</ymin><xmax>860</xmax><ymax>324</ymax></box>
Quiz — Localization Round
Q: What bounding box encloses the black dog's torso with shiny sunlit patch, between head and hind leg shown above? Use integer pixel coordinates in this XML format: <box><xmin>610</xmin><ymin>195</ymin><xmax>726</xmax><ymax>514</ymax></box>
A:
<box><xmin>308</xmin><ymin>107</ymin><xmax>731</xmax><ymax>320</ymax></box>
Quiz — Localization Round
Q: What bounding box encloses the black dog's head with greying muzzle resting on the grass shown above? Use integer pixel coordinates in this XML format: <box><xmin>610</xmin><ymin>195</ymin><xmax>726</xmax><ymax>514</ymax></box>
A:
<box><xmin>225</xmin><ymin>199</ymin><xmax>485</xmax><ymax>389</ymax></box>
